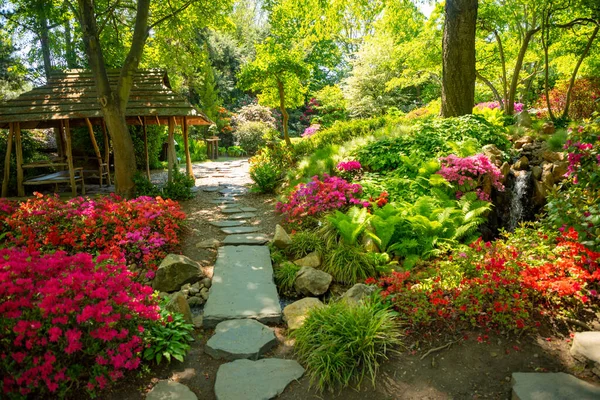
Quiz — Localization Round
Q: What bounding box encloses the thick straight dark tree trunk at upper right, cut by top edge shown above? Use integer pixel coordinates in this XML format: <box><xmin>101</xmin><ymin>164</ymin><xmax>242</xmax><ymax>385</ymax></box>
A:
<box><xmin>442</xmin><ymin>0</ymin><xmax>478</xmax><ymax>117</ymax></box>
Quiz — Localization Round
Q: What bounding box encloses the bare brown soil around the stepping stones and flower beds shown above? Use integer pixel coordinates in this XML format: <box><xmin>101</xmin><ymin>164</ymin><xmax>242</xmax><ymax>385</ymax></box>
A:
<box><xmin>101</xmin><ymin>159</ymin><xmax>600</xmax><ymax>400</ymax></box>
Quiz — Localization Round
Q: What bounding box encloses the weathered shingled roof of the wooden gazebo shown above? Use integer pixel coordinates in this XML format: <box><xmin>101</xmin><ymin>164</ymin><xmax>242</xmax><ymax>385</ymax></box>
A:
<box><xmin>0</xmin><ymin>70</ymin><xmax>212</xmax><ymax>129</ymax></box>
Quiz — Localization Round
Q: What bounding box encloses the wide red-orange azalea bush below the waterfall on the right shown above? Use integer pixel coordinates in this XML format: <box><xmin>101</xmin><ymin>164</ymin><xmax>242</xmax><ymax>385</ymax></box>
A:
<box><xmin>370</xmin><ymin>229</ymin><xmax>600</xmax><ymax>331</ymax></box>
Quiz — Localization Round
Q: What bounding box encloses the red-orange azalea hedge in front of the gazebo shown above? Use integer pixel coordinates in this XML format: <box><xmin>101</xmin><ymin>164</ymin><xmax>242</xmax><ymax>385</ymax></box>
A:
<box><xmin>0</xmin><ymin>194</ymin><xmax>185</xmax><ymax>275</ymax></box>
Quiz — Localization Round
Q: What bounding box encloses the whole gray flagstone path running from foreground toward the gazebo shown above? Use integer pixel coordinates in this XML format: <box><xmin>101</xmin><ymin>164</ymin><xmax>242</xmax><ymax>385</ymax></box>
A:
<box><xmin>194</xmin><ymin>161</ymin><xmax>304</xmax><ymax>400</ymax></box>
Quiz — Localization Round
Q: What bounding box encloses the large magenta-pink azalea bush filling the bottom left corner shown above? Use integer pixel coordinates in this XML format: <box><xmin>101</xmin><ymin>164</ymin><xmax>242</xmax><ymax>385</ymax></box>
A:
<box><xmin>0</xmin><ymin>248</ymin><xmax>159</xmax><ymax>398</ymax></box>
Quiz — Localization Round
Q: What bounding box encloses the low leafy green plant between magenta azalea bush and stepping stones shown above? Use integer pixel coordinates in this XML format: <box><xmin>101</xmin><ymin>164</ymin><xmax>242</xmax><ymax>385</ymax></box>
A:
<box><xmin>143</xmin><ymin>299</ymin><xmax>194</xmax><ymax>364</ymax></box>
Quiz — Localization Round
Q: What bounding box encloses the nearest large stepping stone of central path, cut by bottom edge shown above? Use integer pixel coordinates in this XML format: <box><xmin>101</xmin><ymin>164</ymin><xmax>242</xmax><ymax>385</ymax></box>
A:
<box><xmin>215</xmin><ymin>358</ymin><xmax>304</xmax><ymax>400</ymax></box>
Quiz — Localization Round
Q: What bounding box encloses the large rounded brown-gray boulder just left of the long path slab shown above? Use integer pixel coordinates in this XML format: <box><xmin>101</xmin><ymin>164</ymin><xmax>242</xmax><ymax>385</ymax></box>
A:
<box><xmin>152</xmin><ymin>254</ymin><xmax>202</xmax><ymax>292</ymax></box>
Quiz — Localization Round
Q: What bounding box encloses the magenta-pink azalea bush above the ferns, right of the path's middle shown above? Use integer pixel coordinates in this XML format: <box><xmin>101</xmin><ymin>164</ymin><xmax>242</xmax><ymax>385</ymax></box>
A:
<box><xmin>276</xmin><ymin>174</ymin><xmax>370</xmax><ymax>224</ymax></box>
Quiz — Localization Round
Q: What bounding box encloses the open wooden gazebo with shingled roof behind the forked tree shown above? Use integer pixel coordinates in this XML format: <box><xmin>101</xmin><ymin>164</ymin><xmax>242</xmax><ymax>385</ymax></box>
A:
<box><xmin>0</xmin><ymin>70</ymin><xmax>212</xmax><ymax>197</ymax></box>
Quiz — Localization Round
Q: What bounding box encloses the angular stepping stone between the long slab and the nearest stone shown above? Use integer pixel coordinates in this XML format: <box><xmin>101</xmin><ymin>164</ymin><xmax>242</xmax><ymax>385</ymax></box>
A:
<box><xmin>205</xmin><ymin>319</ymin><xmax>277</xmax><ymax>361</ymax></box>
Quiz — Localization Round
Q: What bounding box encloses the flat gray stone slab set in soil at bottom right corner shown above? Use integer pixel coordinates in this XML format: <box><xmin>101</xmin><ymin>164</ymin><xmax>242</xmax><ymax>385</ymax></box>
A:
<box><xmin>510</xmin><ymin>372</ymin><xmax>600</xmax><ymax>400</ymax></box>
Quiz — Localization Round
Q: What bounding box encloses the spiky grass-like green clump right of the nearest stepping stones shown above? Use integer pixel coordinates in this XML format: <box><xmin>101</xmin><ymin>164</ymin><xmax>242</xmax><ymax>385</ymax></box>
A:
<box><xmin>292</xmin><ymin>299</ymin><xmax>402</xmax><ymax>391</ymax></box>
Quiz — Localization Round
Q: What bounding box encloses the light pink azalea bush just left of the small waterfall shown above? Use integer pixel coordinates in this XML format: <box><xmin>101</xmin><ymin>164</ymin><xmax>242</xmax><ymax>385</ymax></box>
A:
<box><xmin>438</xmin><ymin>154</ymin><xmax>504</xmax><ymax>201</ymax></box>
